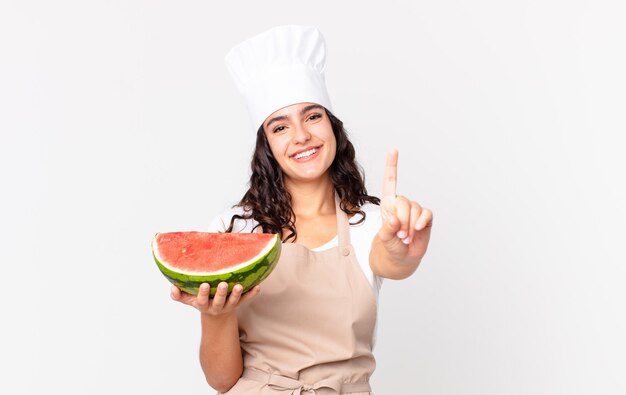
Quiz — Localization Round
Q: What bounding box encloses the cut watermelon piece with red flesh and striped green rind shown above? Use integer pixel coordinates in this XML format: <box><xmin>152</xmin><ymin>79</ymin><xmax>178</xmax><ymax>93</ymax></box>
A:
<box><xmin>152</xmin><ymin>232</ymin><xmax>282</xmax><ymax>296</ymax></box>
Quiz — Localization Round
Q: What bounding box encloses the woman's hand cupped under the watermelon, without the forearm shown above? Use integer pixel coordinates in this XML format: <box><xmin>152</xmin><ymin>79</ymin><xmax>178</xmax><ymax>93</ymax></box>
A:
<box><xmin>170</xmin><ymin>282</ymin><xmax>261</xmax><ymax>317</ymax></box>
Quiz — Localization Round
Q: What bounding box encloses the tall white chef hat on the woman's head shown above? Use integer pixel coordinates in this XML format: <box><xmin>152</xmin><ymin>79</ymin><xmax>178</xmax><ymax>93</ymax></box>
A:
<box><xmin>225</xmin><ymin>25</ymin><xmax>332</xmax><ymax>131</ymax></box>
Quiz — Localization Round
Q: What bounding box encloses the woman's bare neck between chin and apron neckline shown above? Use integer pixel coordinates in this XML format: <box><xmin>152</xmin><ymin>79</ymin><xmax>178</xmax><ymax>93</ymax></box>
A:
<box><xmin>285</xmin><ymin>176</ymin><xmax>335</xmax><ymax>218</ymax></box>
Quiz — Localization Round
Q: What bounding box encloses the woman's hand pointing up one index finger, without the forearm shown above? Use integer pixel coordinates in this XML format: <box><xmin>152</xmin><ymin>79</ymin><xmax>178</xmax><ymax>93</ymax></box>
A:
<box><xmin>378</xmin><ymin>149</ymin><xmax>433</xmax><ymax>264</ymax></box>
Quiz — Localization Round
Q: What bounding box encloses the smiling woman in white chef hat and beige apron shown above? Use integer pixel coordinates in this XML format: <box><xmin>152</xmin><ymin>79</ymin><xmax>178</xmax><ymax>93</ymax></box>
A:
<box><xmin>171</xmin><ymin>26</ymin><xmax>432</xmax><ymax>394</ymax></box>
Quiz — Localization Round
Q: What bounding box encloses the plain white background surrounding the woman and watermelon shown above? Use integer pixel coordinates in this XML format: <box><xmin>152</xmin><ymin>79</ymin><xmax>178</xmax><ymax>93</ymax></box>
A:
<box><xmin>0</xmin><ymin>0</ymin><xmax>626</xmax><ymax>395</ymax></box>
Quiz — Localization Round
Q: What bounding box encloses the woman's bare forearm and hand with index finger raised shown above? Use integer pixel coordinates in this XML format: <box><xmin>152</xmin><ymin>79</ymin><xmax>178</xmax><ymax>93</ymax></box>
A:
<box><xmin>370</xmin><ymin>150</ymin><xmax>433</xmax><ymax>280</ymax></box>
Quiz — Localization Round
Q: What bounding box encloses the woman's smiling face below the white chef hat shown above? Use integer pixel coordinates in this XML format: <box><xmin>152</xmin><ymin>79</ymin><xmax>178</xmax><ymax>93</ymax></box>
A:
<box><xmin>263</xmin><ymin>103</ymin><xmax>337</xmax><ymax>187</ymax></box>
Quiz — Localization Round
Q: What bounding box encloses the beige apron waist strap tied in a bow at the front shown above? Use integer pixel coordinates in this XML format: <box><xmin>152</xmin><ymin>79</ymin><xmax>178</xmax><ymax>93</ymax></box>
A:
<box><xmin>241</xmin><ymin>368</ymin><xmax>372</xmax><ymax>395</ymax></box>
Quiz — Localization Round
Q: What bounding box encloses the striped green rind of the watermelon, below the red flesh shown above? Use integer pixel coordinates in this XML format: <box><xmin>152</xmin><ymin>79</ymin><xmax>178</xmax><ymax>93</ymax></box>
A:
<box><xmin>152</xmin><ymin>235</ymin><xmax>282</xmax><ymax>296</ymax></box>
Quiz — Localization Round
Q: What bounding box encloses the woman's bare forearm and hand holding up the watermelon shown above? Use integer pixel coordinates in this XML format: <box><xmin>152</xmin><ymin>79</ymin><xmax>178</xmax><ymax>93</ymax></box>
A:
<box><xmin>171</xmin><ymin>283</ymin><xmax>260</xmax><ymax>392</ymax></box>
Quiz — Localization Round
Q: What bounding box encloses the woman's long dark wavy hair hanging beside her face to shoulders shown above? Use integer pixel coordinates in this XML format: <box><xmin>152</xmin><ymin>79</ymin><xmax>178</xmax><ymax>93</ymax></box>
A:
<box><xmin>226</xmin><ymin>110</ymin><xmax>380</xmax><ymax>241</ymax></box>
